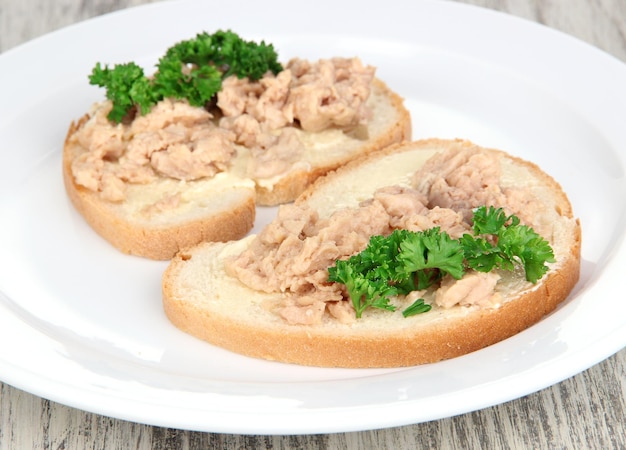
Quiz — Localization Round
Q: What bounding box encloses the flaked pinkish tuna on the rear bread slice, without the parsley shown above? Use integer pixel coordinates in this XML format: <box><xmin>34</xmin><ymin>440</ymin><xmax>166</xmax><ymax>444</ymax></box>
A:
<box><xmin>69</xmin><ymin>58</ymin><xmax>375</xmax><ymax>202</ymax></box>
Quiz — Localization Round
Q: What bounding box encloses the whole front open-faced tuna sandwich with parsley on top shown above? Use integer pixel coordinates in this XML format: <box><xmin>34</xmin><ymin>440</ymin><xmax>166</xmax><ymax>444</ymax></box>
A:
<box><xmin>163</xmin><ymin>140</ymin><xmax>581</xmax><ymax>367</ymax></box>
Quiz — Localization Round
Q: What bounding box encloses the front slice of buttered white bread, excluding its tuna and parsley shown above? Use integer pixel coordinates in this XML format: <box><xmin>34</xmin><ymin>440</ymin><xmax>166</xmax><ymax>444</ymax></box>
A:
<box><xmin>163</xmin><ymin>140</ymin><xmax>580</xmax><ymax>368</ymax></box>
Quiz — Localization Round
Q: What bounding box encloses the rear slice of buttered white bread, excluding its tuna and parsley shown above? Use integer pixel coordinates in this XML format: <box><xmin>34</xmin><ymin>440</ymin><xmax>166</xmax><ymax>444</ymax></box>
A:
<box><xmin>63</xmin><ymin>79</ymin><xmax>411</xmax><ymax>260</ymax></box>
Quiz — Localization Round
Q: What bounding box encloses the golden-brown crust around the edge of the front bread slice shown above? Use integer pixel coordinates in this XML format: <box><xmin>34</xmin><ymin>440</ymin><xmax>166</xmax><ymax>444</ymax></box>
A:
<box><xmin>163</xmin><ymin>140</ymin><xmax>581</xmax><ymax>368</ymax></box>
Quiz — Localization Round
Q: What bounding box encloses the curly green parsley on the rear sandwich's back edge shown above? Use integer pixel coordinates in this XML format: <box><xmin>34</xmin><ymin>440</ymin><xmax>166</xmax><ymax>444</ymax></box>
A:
<box><xmin>89</xmin><ymin>30</ymin><xmax>282</xmax><ymax>123</ymax></box>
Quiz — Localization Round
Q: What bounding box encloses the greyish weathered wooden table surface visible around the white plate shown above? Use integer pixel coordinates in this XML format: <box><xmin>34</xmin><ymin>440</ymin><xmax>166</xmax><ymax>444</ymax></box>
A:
<box><xmin>0</xmin><ymin>0</ymin><xmax>626</xmax><ymax>449</ymax></box>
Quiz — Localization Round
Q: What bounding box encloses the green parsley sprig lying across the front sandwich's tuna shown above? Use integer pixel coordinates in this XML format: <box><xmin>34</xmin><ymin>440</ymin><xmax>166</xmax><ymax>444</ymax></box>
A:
<box><xmin>328</xmin><ymin>206</ymin><xmax>555</xmax><ymax>318</ymax></box>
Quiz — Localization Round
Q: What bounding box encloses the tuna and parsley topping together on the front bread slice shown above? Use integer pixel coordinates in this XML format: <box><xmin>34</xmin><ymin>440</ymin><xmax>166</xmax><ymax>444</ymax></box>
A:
<box><xmin>227</xmin><ymin>148</ymin><xmax>554</xmax><ymax>324</ymax></box>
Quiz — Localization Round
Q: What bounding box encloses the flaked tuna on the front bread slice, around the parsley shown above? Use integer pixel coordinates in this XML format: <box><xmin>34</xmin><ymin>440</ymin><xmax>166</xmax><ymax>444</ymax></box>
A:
<box><xmin>227</xmin><ymin>149</ymin><xmax>540</xmax><ymax>324</ymax></box>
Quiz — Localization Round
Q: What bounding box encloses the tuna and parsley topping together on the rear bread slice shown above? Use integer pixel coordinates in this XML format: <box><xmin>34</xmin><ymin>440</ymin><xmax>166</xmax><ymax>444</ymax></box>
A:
<box><xmin>69</xmin><ymin>32</ymin><xmax>375</xmax><ymax>202</ymax></box>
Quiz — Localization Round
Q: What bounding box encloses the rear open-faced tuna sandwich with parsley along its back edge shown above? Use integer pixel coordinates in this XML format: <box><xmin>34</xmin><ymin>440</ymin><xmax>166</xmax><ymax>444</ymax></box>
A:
<box><xmin>63</xmin><ymin>31</ymin><xmax>411</xmax><ymax>259</ymax></box>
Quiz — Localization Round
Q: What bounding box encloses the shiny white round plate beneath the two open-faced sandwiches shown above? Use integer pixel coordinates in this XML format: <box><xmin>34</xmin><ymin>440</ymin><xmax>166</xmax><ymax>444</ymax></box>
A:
<box><xmin>0</xmin><ymin>0</ymin><xmax>626</xmax><ymax>434</ymax></box>
